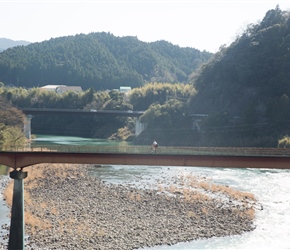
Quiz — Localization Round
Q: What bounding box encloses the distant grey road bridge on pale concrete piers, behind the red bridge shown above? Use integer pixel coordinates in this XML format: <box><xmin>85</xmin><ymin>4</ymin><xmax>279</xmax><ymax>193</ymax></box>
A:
<box><xmin>20</xmin><ymin>108</ymin><xmax>145</xmax><ymax>139</ymax></box>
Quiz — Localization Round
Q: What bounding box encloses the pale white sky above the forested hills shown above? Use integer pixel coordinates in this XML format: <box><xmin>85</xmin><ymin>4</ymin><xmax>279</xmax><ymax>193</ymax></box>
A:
<box><xmin>0</xmin><ymin>0</ymin><xmax>290</xmax><ymax>53</ymax></box>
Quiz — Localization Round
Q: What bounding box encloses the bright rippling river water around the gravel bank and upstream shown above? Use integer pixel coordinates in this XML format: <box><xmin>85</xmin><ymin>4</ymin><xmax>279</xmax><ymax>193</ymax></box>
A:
<box><xmin>0</xmin><ymin>136</ymin><xmax>290</xmax><ymax>250</ymax></box>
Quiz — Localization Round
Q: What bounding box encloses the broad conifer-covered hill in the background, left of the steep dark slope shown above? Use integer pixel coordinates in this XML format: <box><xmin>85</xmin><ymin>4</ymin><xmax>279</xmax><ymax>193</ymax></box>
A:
<box><xmin>0</xmin><ymin>32</ymin><xmax>212</xmax><ymax>90</ymax></box>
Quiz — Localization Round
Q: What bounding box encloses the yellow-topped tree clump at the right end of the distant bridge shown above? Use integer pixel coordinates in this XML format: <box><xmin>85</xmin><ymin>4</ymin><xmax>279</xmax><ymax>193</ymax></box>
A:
<box><xmin>130</xmin><ymin>83</ymin><xmax>198</xmax><ymax>146</ymax></box>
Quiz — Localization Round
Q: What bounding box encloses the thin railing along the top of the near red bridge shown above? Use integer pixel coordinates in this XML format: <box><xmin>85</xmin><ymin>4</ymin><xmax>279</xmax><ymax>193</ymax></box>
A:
<box><xmin>3</xmin><ymin>145</ymin><xmax>290</xmax><ymax>157</ymax></box>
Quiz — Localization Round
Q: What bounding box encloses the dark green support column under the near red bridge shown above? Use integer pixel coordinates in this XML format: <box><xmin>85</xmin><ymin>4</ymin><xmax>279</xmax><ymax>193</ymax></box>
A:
<box><xmin>8</xmin><ymin>170</ymin><xmax>27</xmax><ymax>250</ymax></box>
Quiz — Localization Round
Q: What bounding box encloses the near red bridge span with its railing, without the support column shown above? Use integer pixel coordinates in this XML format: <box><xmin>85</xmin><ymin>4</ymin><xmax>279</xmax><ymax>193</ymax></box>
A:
<box><xmin>0</xmin><ymin>146</ymin><xmax>290</xmax><ymax>169</ymax></box>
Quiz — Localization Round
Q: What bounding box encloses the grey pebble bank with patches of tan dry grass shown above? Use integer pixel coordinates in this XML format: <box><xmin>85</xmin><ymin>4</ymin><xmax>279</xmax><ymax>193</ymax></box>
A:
<box><xmin>2</xmin><ymin>165</ymin><xmax>255</xmax><ymax>250</ymax></box>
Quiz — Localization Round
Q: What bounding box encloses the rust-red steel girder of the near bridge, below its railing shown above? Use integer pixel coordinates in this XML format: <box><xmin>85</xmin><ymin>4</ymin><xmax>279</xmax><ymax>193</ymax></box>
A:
<box><xmin>0</xmin><ymin>151</ymin><xmax>290</xmax><ymax>169</ymax></box>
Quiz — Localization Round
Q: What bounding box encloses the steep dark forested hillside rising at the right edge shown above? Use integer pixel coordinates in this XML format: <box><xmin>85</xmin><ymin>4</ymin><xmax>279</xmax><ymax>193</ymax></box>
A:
<box><xmin>190</xmin><ymin>6</ymin><xmax>290</xmax><ymax>146</ymax></box>
